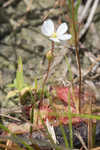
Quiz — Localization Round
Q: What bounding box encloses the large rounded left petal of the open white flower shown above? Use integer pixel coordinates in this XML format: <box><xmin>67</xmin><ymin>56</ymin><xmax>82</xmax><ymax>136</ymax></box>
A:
<box><xmin>41</xmin><ymin>19</ymin><xmax>54</xmax><ymax>36</ymax></box>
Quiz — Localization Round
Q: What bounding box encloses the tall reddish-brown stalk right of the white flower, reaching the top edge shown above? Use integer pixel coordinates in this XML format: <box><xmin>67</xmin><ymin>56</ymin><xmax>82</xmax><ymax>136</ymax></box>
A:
<box><xmin>71</xmin><ymin>0</ymin><xmax>81</xmax><ymax>112</ymax></box>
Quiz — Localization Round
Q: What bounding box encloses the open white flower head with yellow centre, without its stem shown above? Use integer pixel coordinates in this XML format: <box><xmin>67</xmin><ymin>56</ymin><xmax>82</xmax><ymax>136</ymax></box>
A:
<box><xmin>41</xmin><ymin>19</ymin><xmax>72</xmax><ymax>43</ymax></box>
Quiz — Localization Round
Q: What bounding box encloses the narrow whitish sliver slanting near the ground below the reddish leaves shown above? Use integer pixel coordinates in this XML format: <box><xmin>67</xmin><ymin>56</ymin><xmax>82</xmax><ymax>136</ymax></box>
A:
<box><xmin>46</xmin><ymin>119</ymin><xmax>57</xmax><ymax>144</ymax></box>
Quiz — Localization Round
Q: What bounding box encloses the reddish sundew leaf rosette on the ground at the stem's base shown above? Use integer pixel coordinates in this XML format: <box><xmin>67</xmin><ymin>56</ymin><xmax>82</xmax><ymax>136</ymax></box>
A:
<box><xmin>20</xmin><ymin>86</ymin><xmax>93</xmax><ymax>129</ymax></box>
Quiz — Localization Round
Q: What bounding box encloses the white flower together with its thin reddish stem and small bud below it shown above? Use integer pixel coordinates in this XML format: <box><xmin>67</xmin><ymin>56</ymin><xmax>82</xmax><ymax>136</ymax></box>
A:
<box><xmin>41</xmin><ymin>19</ymin><xmax>72</xmax><ymax>103</ymax></box>
